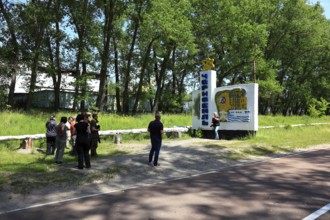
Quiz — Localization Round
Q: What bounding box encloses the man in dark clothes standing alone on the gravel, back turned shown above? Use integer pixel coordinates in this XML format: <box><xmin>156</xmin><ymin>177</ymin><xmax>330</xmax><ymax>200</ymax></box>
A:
<box><xmin>148</xmin><ymin>113</ymin><xmax>164</xmax><ymax>166</ymax></box>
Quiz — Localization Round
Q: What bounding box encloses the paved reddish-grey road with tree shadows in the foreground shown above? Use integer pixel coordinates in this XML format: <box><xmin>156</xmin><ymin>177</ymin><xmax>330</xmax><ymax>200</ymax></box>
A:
<box><xmin>0</xmin><ymin>149</ymin><xmax>330</xmax><ymax>220</ymax></box>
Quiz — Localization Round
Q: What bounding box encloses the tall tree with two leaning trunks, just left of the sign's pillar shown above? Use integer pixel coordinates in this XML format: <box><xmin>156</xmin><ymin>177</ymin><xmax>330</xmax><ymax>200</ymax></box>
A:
<box><xmin>133</xmin><ymin>0</ymin><xmax>194</xmax><ymax>112</ymax></box>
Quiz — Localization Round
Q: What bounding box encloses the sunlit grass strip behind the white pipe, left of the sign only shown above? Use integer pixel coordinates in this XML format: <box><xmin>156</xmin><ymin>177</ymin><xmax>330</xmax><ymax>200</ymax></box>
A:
<box><xmin>0</xmin><ymin>111</ymin><xmax>192</xmax><ymax>136</ymax></box>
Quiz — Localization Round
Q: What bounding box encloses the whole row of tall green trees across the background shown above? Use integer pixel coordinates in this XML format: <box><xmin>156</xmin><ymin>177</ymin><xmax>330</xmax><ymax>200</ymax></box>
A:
<box><xmin>0</xmin><ymin>0</ymin><xmax>330</xmax><ymax>115</ymax></box>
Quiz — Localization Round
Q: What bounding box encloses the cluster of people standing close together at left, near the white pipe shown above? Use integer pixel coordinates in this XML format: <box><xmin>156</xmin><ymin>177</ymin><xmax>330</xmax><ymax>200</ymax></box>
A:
<box><xmin>46</xmin><ymin>112</ymin><xmax>100</xmax><ymax>169</ymax></box>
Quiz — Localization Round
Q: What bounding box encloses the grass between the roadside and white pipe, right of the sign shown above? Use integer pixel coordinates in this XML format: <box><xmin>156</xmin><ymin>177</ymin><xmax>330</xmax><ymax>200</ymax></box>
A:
<box><xmin>218</xmin><ymin>125</ymin><xmax>330</xmax><ymax>160</ymax></box>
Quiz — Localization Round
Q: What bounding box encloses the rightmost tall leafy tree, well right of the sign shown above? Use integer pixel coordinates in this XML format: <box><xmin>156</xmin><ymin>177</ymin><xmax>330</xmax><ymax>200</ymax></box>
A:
<box><xmin>265</xmin><ymin>0</ymin><xmax>329</xmax><ymax>115</ymax></box>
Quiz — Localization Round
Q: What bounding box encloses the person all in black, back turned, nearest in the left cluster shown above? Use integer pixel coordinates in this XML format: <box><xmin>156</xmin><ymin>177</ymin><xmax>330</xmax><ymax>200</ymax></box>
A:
<box><xmin>74</xmin><ymin>114</ymin><xmax>91</xmax><ymax>169</ymax></box>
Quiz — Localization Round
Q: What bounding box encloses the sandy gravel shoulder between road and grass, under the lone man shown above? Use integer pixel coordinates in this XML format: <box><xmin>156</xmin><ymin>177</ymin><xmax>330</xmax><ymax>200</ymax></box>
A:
<box><xmin>0</xmin><ymin>138</ymin><xmax>330</xmax><ymax>214</ymax></box>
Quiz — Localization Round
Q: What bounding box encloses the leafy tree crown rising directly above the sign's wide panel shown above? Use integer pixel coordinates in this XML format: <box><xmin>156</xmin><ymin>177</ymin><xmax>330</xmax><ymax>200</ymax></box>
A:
<box><xmin>192</xmin><ymin>0</ymin><xmax>267</xmax><ymax>86</ymax></box>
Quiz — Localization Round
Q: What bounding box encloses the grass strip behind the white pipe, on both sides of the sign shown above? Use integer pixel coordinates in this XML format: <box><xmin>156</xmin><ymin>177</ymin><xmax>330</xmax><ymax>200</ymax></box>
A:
<box><xmin>0</xmin><ymin>111</ymin><xmax>330</xmax><ymax>136</ymax></box>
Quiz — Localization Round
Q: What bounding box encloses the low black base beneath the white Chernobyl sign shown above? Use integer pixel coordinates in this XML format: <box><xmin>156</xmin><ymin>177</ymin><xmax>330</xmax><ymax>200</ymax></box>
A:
<box><xmin>202</xmin><ymin>130</ymin><xmax>257</xmax><ymax>140</ymax></box>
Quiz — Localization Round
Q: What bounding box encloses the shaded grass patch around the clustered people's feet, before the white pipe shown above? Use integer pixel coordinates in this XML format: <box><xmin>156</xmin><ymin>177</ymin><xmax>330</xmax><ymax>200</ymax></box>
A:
<box><xmin>0</xmin><ymin>139</ymin><xmax>134</xmax><ymax>194</ymax></box>
